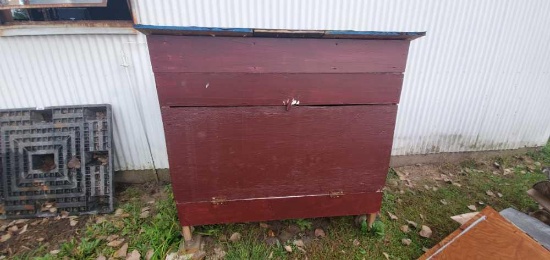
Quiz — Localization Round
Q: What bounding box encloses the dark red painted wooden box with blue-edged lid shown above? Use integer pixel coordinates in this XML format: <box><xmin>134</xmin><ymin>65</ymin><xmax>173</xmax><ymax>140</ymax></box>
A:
<box><xmin>141</xmin><ymin>28</ymin><xmax>423</xmax><ymax>226</ymax></box>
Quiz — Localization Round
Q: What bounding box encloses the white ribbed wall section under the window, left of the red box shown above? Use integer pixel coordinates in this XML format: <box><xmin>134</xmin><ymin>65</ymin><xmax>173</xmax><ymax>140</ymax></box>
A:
<box><xmin>0</xmin><ymin>34</ymin><xmax>168</xmax><ymax>170</ymax></box>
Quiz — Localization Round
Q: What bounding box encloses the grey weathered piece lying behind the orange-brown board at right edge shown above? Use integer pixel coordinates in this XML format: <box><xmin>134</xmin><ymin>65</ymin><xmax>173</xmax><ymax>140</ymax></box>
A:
<box><xmin>500</xmin><ymin>208</ymin><xmax>550</xmax><ymax>250</ymax></box>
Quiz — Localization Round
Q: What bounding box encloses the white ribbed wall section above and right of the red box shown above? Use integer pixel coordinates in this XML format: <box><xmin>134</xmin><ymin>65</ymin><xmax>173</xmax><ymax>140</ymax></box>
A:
<box><xmin>134</xmin><ymin>0</ymin><xmax>550</xmax><ymax>155</ymax></box>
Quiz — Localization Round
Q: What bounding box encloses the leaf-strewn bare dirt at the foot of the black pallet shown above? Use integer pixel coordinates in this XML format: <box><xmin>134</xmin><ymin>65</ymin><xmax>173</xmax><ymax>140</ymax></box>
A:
<box><xmin>0</xmin><ymin>216</ymin><xmax>89</xmax><ymax>257</ymax></box>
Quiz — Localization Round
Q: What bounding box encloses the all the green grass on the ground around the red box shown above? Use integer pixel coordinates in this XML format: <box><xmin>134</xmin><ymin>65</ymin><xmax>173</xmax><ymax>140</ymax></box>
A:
<box><xmin>11</xmin><ymin>143</ymin><xmax>550</xmax><ymax>259</ymax></box>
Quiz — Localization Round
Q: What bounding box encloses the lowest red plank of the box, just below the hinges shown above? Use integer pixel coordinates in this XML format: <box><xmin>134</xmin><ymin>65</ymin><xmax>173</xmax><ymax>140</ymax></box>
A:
<box><xmin>176</xmin><ymin>192</ymin><xmax>382</xmax><ymax>226</ymax></box>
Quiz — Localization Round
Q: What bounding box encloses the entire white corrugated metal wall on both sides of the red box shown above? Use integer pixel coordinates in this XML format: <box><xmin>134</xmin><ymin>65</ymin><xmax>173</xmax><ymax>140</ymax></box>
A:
<box><xmin>0</xmin><ymin>0</ymin><xmax>550</xmax><ymax>169</ymax></box>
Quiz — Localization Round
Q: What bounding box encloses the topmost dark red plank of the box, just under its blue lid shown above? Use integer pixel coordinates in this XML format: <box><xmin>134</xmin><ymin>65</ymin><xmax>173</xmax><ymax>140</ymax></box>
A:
<box><xmin>147</xmin><ymin>35</ymin><xmax>409</xmax><ymax>73</ymax></box>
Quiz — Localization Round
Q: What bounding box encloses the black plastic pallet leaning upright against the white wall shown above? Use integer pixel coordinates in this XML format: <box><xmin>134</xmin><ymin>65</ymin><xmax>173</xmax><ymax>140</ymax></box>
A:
<box><xmin>0</xmin><ymin>105</ymin><xmax>114</xmax><ymax>218</ymax></box>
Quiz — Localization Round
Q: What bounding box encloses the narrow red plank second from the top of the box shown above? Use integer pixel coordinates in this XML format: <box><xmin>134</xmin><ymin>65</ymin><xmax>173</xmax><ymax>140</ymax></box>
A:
<box><xmin>155</xmin><ymin>72</ymin><xmax>403</xmax><ymax>106</ymax></box>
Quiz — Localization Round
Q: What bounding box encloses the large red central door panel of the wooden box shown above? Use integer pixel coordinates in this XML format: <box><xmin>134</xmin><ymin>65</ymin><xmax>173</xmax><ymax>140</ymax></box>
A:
<box><xmin>161</xmin><ymin>105</ymin><xmax>397</xmax><ymax>203</ymax></box>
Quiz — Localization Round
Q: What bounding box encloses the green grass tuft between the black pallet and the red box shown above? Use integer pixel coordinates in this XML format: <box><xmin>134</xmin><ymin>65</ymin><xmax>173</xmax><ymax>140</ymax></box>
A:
<box><xmin>15</xmin><ymin>186</ymin><xmax>181</xmax><ymax>260</ymax></box>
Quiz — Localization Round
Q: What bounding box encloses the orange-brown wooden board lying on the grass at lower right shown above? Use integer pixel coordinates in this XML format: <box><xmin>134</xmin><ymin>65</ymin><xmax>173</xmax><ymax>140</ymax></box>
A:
<box><xmin>419</xmin><ymin>207</ymin><xmax>550</xmax><ymax>259</ymax></box>
